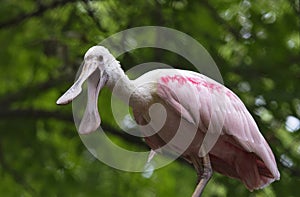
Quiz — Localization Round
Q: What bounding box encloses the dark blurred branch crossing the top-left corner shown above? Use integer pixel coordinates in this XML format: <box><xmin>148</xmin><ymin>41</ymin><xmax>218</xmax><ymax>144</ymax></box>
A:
<box><xmin>0</xmin><ymin>0</ymin><xmax>77</xmax><ymax>29</ymax></box>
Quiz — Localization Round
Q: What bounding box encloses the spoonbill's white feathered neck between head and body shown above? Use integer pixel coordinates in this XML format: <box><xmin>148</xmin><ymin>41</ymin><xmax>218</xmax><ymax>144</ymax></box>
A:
<box><xmin>106</xmin><ymin>61</ymin><xmax>143</xmax><ymax>107</ymax></box>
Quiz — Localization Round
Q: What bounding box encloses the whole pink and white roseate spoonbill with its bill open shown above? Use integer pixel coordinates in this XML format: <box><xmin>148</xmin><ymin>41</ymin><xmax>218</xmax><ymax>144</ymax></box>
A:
<box><xmin>57</xmin><ymin>46</ymin><xmax>280</xmax><ymax>197</ymax></box>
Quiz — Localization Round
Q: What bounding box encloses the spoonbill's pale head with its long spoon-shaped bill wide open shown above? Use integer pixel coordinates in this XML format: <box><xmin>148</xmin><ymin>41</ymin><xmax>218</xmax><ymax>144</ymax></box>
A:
<box><xmin>56</xmin><ymin>46</ymin><xmax>115</xmax><ymax>134</ymax></box>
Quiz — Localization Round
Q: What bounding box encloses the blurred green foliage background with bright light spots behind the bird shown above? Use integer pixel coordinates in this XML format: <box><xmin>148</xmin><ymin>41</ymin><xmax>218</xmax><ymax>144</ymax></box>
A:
<box><xmin>0</xmin><ymin>0</ymin><xmax>300</xmax><ymax>197</ymax></box>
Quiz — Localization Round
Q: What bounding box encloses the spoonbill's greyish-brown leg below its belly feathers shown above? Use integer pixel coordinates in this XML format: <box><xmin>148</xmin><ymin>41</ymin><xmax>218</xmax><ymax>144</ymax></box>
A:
<box><xmin>192</xmin><ymin>154</ymin><xmax>212</xmax><ymax>197</ymax></box>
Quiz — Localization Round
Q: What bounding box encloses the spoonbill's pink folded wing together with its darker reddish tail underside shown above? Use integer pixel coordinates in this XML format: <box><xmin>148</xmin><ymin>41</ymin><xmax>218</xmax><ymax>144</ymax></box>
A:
<box><xmin>150</xmin><ymin>71</ymin><xmax>280</xmax><ymax>191</ymax></box>
